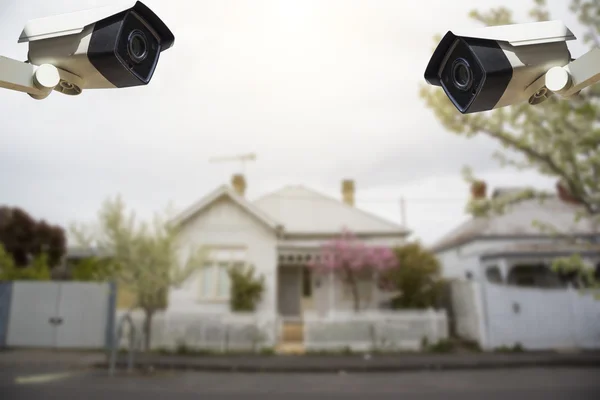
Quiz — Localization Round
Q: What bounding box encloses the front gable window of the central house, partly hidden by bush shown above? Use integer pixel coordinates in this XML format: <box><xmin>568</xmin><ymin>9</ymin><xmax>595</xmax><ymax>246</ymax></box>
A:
<box><xmin>199</xmin><ymin>248</ymin><xmax>246</xmax><ymax>301</ymax></box>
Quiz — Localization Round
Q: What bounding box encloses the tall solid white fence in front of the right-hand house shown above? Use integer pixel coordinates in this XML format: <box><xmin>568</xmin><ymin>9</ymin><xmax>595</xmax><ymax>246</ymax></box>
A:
<box><xmin>452</xmin><ymin>281</ymin><xmax>600</xmax><ymax>350</ymax></box>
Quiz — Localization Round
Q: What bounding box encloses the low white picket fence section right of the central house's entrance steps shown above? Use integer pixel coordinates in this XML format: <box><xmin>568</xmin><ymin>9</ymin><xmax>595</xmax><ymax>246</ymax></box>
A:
<box><xmin>304</xmin><ymin>310</ymin><xmax>448</xmax><ymax>351</ymax></box>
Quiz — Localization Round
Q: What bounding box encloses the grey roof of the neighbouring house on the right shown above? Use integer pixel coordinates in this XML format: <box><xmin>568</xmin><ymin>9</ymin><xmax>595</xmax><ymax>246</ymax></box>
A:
<box><xmin>432</xmin><ymin>188</ymin><xmax>595</xmax><ymax>252</ymax></box>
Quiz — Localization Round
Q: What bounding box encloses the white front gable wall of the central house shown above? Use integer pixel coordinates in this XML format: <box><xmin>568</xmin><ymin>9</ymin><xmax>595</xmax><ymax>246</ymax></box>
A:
<box><xmin>168</xmin><ymin>196</ymin><xmax>277</xmax><ymax>315</ymax></box>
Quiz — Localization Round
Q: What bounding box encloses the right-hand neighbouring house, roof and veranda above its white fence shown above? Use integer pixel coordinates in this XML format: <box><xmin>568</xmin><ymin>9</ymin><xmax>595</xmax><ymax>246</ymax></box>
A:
<box><xmin>432</xmin><ymin>188</ymin><xmax>600</xmax><ymax>287</ymax></box>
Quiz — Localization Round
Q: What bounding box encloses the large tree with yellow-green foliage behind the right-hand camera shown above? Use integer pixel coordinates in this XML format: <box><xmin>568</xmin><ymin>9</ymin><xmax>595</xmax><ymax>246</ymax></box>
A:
<box><xmin>421</xmin><ymin>0</ymin><xmax>600</xmax><ymax>288</ymax></box>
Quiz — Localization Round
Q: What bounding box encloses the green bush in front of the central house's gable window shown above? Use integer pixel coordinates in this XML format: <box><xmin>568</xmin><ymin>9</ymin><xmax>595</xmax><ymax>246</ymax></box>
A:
<box><xmin>228</xmin><ymin>266</ymin><xmax>265</xmax><ymax>312</ymax></box>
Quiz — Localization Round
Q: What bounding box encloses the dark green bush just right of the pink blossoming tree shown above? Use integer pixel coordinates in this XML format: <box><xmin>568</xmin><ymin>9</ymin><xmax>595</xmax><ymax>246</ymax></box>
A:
<box><xmin>381</xmin><ymin>242</ymin><xmax>444</xmax><ymax>308</ymax></box>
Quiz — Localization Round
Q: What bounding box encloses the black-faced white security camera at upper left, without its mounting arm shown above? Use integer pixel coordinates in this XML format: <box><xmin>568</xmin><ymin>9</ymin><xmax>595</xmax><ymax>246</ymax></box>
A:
<box><xmin>19</xmin><ymin>1</ymin><xmax>175</xmax><ymax>95</ymax></box>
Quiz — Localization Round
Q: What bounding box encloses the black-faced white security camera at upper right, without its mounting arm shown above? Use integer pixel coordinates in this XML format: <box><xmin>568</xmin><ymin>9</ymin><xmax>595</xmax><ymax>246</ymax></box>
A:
<box><xmin>425</xmin><ymin>21</ymin><xmax>575</xmax><ymax>114</ymax></box>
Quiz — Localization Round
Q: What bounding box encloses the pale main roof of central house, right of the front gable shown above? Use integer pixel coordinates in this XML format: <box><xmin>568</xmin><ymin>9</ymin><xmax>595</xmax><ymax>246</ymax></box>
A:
<box><xmin>254</xmin><ymin>186</ymin><xmax>409</xmax><ymax>236</ymax></box>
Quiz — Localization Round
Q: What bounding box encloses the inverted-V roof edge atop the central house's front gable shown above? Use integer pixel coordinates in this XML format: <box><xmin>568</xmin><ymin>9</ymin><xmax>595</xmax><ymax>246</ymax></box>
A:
<box><xmin>170</xmin><ymin>185</ymin><xmax>281</xmax><ymax>230</ymax></box>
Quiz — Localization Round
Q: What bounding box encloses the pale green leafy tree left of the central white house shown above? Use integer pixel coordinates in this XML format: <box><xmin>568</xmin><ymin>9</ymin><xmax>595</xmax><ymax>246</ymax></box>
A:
<box><xmin>71</xmin><ymin>197</ymin><xmax>204</xmax><ymax>349</ymax></box>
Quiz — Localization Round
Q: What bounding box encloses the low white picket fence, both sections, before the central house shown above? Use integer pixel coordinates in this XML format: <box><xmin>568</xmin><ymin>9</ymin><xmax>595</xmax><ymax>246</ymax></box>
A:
<box><xmin>117</xmin><ymin>310</ymin><xmax>448</xmax><ymax>352</ymax></box>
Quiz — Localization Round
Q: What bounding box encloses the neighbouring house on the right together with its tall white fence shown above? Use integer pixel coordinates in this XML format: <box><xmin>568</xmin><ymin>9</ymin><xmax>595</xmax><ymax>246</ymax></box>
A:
<box><xmin>433</xmin><ymin>184</ymin><xmax>600</xmax><ymax>349</ymax></box>
